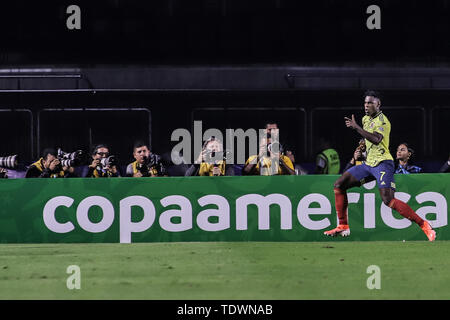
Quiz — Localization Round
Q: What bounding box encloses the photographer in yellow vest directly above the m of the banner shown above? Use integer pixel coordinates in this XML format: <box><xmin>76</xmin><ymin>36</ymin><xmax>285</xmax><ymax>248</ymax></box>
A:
<box><xmin>242</xmin><ymin>134</ymin><xmax>295</xmax><ymax>176</ymax></box>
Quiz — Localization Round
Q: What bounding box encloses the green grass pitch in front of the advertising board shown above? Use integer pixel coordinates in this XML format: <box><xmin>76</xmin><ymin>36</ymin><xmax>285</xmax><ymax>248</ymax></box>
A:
<box><xmin>0</xmin><ymin>241</ymin><xmax>450</xmax><ymax>300</ymax></box>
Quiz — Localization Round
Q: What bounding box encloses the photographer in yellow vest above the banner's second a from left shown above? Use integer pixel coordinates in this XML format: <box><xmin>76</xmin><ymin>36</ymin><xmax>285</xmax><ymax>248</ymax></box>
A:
<box><xmin>185</xmin><ymin>136</ymin><xmax>234</xmax><ymax>176</ymax></box>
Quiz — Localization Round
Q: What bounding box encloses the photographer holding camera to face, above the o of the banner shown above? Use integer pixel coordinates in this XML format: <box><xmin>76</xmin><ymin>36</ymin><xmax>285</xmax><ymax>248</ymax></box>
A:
<box><xmin>82</xmin><ymin>144</ymin><xmax>120</xmax><ymax>178</ymax></box>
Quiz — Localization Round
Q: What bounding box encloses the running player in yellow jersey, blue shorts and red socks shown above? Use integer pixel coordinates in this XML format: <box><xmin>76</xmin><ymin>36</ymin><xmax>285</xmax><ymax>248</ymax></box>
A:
<box><xmin>324</xmin><ymin>91</ymin><xmax>436</xmax><ymax>241</ymax></box>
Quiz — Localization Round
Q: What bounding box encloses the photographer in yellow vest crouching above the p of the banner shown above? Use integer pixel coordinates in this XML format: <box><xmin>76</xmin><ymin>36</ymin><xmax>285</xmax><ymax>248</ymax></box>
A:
<box><xmin>126</xmin><ymin>141</ymin><xmax>166</xmax><ymax>178</ymax></box>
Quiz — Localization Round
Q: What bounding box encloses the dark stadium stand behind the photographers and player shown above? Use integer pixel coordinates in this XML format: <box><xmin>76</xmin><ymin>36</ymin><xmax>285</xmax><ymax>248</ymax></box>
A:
<box><xmin>0</xmin><ymin>0</ymin><xmax>450</xmax><ymax>172</ymax></box>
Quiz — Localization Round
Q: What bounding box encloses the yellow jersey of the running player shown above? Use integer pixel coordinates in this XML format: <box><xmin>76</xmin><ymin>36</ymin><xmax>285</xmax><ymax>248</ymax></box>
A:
<box><xmin>362</xmin><ymin>111</ymin><xmax>394</xmax><ymax>167</ymax></box>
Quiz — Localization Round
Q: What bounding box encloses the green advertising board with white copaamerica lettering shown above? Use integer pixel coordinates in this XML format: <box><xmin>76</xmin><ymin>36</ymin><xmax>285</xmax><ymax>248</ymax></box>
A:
<box><xmin>0</xmin><ymin>174</ymin><xmax>450</xmax><ymax>243</ymax></box>
